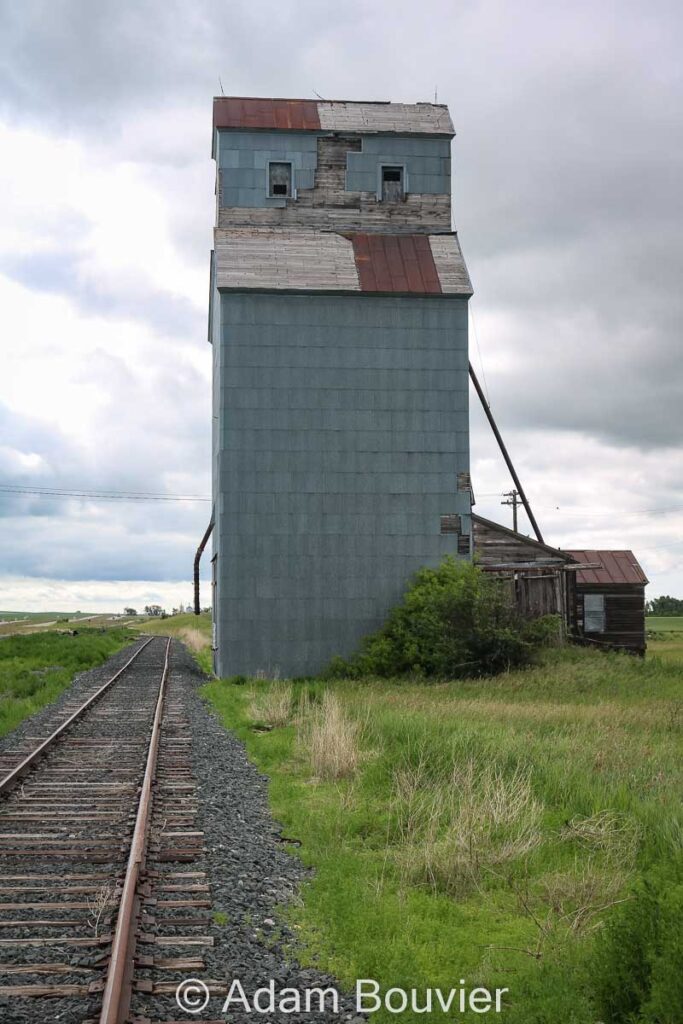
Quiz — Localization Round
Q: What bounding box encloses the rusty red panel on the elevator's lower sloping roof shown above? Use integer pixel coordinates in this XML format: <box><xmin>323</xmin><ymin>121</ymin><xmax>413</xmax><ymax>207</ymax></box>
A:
<box><xmin>347</xmin><ymin>233</ymin><xmax>441</xmax><ymax>295</ymax></box>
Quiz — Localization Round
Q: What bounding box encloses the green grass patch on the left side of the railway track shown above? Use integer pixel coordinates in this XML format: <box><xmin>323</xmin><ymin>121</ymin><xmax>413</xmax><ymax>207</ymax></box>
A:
<box><xmin>0</xmin><ymin>628</ymin><xmax>133</xmax><ymax>736</ymax></box>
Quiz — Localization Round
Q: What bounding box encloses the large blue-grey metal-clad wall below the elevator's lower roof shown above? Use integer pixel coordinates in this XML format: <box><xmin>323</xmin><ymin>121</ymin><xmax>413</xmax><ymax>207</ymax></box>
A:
<box><xmin>214</xmin><ymin>293</ymin><xmax>470</xmax><ymax>676</ymax></box>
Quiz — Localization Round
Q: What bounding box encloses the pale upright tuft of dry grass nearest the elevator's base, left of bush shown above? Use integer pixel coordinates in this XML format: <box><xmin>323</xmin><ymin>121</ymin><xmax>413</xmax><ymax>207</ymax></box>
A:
<box><xmin>297</xmin><ymin>690</ymin><xmax>362</xmax><ymax>780</ymax></box>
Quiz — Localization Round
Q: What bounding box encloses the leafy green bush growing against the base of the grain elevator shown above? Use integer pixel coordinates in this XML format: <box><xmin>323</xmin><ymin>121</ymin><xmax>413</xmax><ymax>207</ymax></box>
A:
<box><xmin>327</xmin><ymin>556</ymin><xmax>544</xmax><ymax>678</ymax></box>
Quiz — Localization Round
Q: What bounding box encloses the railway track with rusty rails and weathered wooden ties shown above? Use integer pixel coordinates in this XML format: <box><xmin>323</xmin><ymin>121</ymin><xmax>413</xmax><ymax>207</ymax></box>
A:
<box><xmin>0</xmin><ymin>638</ymin><xmax>223</xmax><ymax>1024</ymax></box>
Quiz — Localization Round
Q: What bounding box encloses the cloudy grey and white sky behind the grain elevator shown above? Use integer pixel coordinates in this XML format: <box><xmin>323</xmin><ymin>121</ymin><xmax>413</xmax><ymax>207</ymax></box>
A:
<box><xmin>0</xmin><ymin>0</ymin><xmax>683</xmax><ymax>610</ymax></box>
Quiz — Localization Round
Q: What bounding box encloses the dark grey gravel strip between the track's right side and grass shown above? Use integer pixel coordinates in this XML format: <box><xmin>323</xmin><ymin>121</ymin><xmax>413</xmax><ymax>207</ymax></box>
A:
<box><xmin>158</xmin><ymin>642</ymin><xmax>364</xmax><ymax>1024</ymax></box>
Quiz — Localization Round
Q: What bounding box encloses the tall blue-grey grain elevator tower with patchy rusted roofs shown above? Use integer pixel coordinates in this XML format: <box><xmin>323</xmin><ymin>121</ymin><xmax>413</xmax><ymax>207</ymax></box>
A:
<box><xmin>210</xmin><ymin>97</ymin><xmax>472</xmax><ymax>676</ymax></box>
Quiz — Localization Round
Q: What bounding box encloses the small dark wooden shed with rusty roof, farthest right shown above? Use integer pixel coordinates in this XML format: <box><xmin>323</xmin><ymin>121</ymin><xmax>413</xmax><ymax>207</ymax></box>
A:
<box><xmin>567</xmin><ymin>551</ymin><xmax>648</xmax><ymax>654</ymax></box>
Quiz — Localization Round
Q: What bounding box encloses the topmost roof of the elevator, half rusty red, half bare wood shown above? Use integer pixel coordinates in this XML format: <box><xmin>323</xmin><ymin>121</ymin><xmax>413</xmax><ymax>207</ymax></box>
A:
<box><xmin>213</xmin><ymin>96</ymin><xmax>455</xmax><ymax>137</ymax></box>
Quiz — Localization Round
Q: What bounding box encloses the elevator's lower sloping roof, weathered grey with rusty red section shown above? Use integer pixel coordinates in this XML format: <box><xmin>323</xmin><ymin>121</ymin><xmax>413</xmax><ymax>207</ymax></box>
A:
<box><xmin>214</xmin><ymin>227</ymin><xmax>472</xmax><ymax>295</ymax></box>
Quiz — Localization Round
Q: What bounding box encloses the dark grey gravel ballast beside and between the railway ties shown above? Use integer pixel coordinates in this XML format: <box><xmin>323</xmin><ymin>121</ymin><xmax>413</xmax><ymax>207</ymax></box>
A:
<box><xmin>0</xmin><ymin>641</ymin><xmax>364</xmax><ymax>1024</ymax></box>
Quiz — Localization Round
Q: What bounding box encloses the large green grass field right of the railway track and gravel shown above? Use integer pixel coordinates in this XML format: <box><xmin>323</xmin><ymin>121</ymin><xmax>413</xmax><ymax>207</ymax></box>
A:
<box><xmin>204</xmin><ymin>644</ymin><xmax>683</xmax><ymax>1024</ymax></box>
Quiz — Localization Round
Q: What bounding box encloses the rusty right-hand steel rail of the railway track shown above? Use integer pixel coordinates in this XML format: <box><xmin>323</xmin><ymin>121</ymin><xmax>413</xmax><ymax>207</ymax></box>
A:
<box><xmin>99</xmin><ymin>638</ymin><xmax>171</xmax><ymax>1024</ymax></box>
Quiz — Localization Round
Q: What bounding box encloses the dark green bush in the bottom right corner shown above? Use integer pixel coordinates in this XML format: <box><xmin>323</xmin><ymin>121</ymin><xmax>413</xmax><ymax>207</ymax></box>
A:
<box><xmin>593</xmin><ymin>872</ymin><xmax>683</xmax><ymax>1024</ymax></box>
